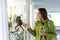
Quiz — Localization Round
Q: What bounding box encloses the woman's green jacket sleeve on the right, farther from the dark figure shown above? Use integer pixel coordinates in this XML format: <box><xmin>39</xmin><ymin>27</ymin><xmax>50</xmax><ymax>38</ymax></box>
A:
<box><xmin>47</xmin><ymin>21</ymin><xmax>57</xmax><ymax>40</ymax></box>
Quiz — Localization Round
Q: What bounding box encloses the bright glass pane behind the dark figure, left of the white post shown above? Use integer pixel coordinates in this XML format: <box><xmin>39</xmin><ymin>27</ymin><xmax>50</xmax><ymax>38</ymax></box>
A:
<box><xmin>7</xmin><ymin>0</ymin><xmax>26</xmax><ymax>40</ymax></box>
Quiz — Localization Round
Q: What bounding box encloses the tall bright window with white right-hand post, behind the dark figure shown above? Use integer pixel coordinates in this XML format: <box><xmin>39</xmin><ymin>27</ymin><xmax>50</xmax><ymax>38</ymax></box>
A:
<box><xmin>7</xmin><ymin>0</ymin><xmax>33</xmax><ymax>40</ymax></box>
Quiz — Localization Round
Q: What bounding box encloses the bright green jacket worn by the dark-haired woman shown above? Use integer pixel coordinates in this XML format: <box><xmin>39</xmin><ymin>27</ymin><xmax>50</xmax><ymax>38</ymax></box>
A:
<box><xmin>28</xmin><ymin>19</ymin><xmax>56</xmax><ymax>40</ymax></box>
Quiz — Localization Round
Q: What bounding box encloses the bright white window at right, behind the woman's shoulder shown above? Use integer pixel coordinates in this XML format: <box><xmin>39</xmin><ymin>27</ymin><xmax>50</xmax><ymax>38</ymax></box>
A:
<box><xmin>48</xmin><ymin>13</ymin><xmax>60</xmax><ymax>26</ymax></box>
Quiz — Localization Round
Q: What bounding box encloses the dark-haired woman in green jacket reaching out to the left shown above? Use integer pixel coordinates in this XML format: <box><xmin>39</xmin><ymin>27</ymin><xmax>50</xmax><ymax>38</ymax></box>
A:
<box><xmin>24</xmin><ymin>8</ymin><xmax>56</xmax><ymax>40</ymax></box>
